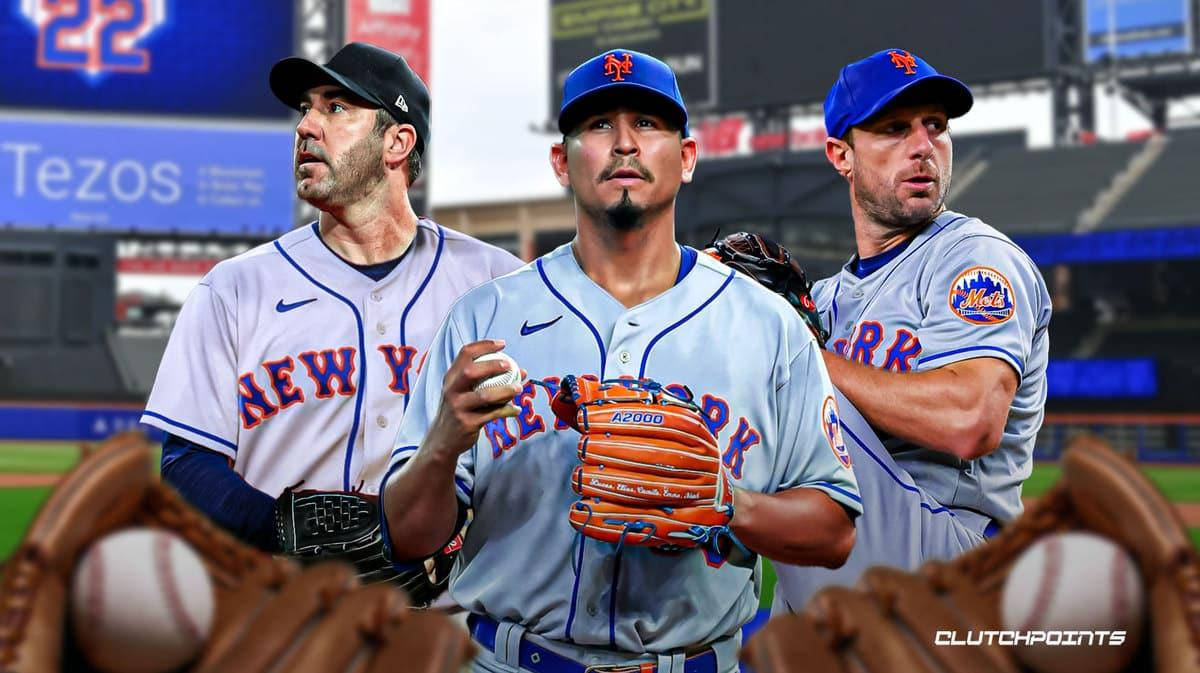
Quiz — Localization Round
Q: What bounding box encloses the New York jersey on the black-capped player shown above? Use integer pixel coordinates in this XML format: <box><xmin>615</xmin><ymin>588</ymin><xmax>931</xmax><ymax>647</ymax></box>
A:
<box><xmin>142</xmin><ymin>220</ymin><xmax>521</xmax><ymax>495</ymax></box>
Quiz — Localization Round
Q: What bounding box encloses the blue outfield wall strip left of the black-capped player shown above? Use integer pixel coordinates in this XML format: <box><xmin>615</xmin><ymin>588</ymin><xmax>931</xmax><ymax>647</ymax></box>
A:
<box><xmin>0</xmin><ymin>403</ymin><xmax>163</xmax><ymax>441</ymax></box>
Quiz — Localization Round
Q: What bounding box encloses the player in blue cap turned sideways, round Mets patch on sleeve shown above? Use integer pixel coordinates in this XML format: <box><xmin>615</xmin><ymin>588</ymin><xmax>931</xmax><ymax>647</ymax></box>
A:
<box><xmin>774</xmin><ymin>49</ymin><xmax>1050</xmax><ymax>611</ymax></box>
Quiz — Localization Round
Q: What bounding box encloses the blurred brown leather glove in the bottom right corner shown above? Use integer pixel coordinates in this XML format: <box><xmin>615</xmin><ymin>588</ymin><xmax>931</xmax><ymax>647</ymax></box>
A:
<box><xmin>742</xmin><ymin>437</ymin><xmax>1200</xmax><ymax>673</ymax></box>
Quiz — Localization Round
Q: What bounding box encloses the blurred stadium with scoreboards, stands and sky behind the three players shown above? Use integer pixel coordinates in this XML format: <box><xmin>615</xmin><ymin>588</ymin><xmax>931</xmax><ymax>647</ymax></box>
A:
<box><xmin>0</xmin><ymin>0</ymin><xmax>1200</xmax><ymax>461</ymax></box>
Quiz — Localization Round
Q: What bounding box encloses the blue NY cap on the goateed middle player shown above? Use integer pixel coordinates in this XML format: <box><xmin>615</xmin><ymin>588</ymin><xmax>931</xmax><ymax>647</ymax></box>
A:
<box><xmin>558</xmin><ymin>49</ymin><xmax>689</xmax><ymax>138</ymax></box>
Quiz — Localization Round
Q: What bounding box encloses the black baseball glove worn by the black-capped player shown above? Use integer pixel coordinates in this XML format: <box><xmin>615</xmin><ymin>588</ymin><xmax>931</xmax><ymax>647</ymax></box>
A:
<box><xmin>275</xmin><ymin>489</ymin><xmax>460</xmax><ymax>607</ymax></box>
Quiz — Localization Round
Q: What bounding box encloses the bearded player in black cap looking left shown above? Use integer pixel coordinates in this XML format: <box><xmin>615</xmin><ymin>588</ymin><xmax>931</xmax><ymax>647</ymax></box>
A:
<box><xmin>142</xmin><ymin>43</ymin><xmax>521</xmax><ymax>592</ymax></box>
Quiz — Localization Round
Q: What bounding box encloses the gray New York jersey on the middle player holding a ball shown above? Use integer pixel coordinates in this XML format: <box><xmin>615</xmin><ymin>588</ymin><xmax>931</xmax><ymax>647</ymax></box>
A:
<box><xmin>388</xmin><ymin>245</ymin><xmax>860</xmax><ymax>653</ymax></box>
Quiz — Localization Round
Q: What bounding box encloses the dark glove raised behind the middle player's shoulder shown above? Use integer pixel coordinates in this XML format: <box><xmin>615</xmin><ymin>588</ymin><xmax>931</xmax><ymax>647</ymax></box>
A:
<box><xmin>704</xmin><ymin>232</ymin><xmax>829</xmax><ymax>348</ymax></box>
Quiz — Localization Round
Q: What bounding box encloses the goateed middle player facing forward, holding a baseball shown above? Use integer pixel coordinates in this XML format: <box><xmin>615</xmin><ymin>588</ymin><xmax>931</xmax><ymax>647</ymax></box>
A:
<box><xmin>382</xmin><ymin>49</ymin><xmax>860</xmax><ymax>673</ymax></box>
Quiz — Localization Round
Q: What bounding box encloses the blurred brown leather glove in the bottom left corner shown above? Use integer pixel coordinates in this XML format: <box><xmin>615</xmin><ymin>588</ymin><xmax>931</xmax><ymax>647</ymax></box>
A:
<box><xmin>0</xmin><ymin>433</ymin><xmax>473</xmax><ymax>673</ymax></box>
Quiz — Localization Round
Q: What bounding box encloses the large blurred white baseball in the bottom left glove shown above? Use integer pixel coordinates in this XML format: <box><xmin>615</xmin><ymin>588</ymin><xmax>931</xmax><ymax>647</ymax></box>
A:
<box><xmin>71</xmin><ymin>528</ymin><xmax>215</xmax><ymax>673</ymax></box>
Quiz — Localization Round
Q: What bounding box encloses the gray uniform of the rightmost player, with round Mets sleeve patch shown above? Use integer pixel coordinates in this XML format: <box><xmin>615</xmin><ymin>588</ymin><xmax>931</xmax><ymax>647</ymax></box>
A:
<box><xmin>772</xmin><ymin>212</ymin><xmax>1050</xmax><ymax>613</ymax></box>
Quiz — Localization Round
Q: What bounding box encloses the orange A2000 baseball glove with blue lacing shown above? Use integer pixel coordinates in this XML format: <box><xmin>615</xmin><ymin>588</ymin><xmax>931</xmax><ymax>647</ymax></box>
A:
<box><xmin>551</xmin><ymin>375</ymin><xmax>740</xmax><ymax>557</ymax></box>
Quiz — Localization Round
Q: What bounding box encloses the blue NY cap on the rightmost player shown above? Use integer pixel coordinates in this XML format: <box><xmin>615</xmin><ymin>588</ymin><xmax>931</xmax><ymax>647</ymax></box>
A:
<box><xmin>824</xmin><ymin>49</ymin><xmax>974</xmax><ymax>138</ymax></box>
